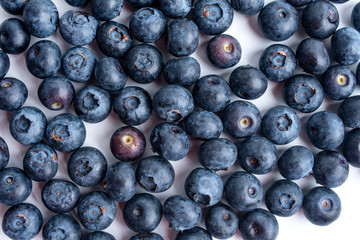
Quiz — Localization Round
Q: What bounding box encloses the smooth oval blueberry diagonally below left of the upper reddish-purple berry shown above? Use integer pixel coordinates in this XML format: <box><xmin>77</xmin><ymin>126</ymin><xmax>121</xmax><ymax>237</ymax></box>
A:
<box><xmin>163</xmin><ymin>57</ymin><xmax>201</xmax><ymax>86</ymax></box>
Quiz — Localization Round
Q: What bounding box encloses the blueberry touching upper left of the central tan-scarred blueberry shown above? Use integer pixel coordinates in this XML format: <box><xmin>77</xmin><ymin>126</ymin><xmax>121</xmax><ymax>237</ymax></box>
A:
<box><xmin>192</xmin><ymin>75</ymin><xmax>231</xmax><ymax>112</ymax></box>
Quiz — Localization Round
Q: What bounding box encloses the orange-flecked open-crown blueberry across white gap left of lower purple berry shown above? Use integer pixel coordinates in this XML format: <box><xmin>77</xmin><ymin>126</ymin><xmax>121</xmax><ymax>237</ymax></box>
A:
<box><xmin>45</xmin><ymin>113</ymin><xmax>86</xmax><ymax>152</ymax></box>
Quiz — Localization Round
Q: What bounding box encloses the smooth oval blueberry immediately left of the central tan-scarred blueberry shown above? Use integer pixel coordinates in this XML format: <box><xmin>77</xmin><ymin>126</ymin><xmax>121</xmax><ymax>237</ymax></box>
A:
<box><xmin>184</xmin><ymin>111</ymin><xmax>223</xmax><ymax>140</ymax></box>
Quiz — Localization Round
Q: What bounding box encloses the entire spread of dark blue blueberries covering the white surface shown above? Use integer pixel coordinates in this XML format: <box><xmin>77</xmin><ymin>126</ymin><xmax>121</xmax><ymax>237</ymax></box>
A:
<box><xmin>0</xmin><ymin>0</ymin><xmax>360</xmax><ymax>240</ymax></box>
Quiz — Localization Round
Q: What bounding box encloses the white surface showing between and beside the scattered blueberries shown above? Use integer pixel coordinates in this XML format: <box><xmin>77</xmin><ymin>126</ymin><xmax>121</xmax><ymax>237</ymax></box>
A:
<box><xmin>0</xmin><ymin>0</ymin><xmax>360</xmax><ymax>240</ymax></box>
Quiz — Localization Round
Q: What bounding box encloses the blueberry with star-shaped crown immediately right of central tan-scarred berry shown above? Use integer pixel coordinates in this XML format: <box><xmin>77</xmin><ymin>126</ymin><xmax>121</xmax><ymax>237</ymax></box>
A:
<box><xmin>261</xmin><ymin>105</ymin><xmax>301</xmax><ymax>145</ymax></box>
